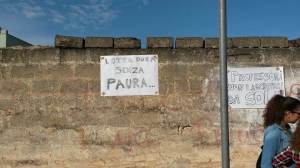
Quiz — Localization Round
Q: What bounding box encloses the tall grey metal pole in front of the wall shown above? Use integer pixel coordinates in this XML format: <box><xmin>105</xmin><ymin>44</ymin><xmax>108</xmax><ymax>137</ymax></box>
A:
<box><xmin>219</xmin><ymin>0</ymin><xmax>230</xmax><ymax>168</ymax></box>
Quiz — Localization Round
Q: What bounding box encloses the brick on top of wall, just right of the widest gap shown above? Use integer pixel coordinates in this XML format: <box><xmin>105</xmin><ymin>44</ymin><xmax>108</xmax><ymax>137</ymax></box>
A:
<box><xmin>147</xmin><ymin>37</ymin><xmax>174</xmax><ymax>48</ymax></box>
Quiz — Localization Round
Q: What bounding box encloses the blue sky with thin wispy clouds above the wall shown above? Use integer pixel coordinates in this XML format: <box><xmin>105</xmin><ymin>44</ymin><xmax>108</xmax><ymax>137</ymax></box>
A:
<box><xmin>0</xmin><ymin>0</ymin><xmax>300</xmax><ymax>46</ymax></box>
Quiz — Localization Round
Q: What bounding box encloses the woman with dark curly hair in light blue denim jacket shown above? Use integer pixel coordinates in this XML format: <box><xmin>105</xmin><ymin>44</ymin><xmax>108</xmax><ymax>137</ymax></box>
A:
<box><xmin>261</xmin><ymin>95</ymin><xmax>300</xmax><ymax>168</ymax></box>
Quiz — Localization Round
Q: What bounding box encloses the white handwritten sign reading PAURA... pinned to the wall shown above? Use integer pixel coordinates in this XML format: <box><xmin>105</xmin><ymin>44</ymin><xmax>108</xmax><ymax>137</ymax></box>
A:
<box><xmin>100</xmin><ymin>55</ymin><xmax>159</xmax><ymax>96</ymax></box>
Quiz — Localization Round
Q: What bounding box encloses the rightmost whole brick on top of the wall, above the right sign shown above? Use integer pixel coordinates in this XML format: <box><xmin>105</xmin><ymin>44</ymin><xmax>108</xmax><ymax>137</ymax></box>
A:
<box><xmin>260</xmin><ymin>37</ymin><xmax>288</xmax><ymax>47</ymax></box>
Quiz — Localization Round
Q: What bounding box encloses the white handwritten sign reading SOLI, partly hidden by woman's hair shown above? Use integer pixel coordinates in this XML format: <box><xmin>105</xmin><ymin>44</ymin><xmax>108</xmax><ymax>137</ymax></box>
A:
<box><xmin>228</xmin><ymin>67</ymin><xmax>285</xmax><ymax>108</ymax></box>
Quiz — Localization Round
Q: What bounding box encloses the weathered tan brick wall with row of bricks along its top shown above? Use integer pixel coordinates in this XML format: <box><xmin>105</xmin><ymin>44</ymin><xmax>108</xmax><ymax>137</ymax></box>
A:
<box><xmin>0</xmin><ymin>37</ymin><xmax>300</xmax><ymax>168</ymax></box>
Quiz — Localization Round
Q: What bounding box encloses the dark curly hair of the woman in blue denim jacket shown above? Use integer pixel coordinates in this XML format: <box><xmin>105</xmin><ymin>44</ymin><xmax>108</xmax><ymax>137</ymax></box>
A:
<box><xmin>263</xmin><ymin>95</ymin><xmax>300</xmax><ymax>128</ymax></box>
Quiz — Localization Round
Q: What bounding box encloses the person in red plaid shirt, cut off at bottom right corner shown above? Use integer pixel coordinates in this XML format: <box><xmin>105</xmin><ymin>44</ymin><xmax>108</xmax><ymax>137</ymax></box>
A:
<box><xmin>272</xmin><ymin>120</ymin><xmax>300</xmax><ymax>168</ymax></box>
